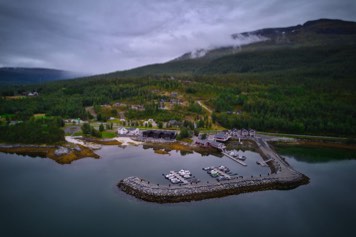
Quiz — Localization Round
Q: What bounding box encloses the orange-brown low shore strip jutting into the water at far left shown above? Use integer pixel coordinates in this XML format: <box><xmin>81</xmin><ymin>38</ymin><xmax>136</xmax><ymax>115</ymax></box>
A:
<box><xmin>0</xmin><ymin>145</ymin><xmax>99</xmax><ymax>164</ymax></box>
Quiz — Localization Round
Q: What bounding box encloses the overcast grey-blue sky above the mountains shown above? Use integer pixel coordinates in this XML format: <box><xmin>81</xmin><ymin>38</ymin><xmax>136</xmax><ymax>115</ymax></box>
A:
<box><xmin>0</xmin><ymin>0</ymin><xmax>356</xmax><ymax>74</ymax></box>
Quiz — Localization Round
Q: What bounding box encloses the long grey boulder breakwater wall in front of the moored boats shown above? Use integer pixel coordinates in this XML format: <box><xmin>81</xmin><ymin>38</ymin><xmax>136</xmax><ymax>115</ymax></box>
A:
<box><xmin>118</xmin><ymin>171</ymin><xmax>309</xmax><ymax>203</ymax></box>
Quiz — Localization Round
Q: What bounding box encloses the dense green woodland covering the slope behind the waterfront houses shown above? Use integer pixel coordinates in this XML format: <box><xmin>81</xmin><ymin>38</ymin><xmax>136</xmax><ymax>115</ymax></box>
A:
<box><xmin>0</xmin><ymin>46</ymin><xmax>356</xmax><ymax>137</ymax></box>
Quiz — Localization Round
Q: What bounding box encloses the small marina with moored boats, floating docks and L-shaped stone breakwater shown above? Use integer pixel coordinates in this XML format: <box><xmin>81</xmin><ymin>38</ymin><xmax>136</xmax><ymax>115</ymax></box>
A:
<box><xmin>118</xmin><ymin>138</ymin><xmax>309</xmax><ymax>203</ymax></box>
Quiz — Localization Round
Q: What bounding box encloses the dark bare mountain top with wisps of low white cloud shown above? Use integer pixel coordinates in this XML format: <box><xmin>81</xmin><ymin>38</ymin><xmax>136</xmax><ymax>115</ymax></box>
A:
<box><xmin>173</xmin><ymin>19</ymin><xmax>356</xmax><ymax>61</ymax></box>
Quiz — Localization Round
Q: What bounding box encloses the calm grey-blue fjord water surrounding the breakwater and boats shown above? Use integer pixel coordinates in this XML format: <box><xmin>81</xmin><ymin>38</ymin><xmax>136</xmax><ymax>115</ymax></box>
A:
<box><xmin>0</xmin><ymin>146</ymin><xmax>356</xmax><ymax>237</ymax></box>
